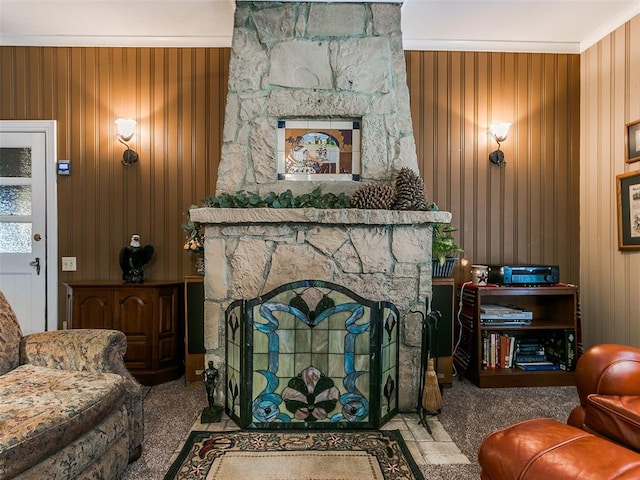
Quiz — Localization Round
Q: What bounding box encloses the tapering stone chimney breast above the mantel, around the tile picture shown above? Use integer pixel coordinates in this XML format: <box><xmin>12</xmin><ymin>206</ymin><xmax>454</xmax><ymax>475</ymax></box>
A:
<box><xmin>216</xmin><ymin>2</ymin><xmax>418</xmax><ymax>195</ymax></box>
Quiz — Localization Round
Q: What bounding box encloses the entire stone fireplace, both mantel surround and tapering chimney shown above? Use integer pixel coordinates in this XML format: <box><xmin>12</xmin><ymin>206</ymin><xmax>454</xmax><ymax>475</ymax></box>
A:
<box><xmin>191</xmin><ymin>2</ymin><xmax>451</xmax><ymax>411</ymax></box>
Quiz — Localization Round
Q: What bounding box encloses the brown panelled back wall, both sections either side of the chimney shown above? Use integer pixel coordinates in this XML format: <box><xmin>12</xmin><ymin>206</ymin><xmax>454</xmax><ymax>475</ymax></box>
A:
<box><xmin>0</xmin><ymin>47</ymin><xmax>579</xmax><ymax>326</ymax></box>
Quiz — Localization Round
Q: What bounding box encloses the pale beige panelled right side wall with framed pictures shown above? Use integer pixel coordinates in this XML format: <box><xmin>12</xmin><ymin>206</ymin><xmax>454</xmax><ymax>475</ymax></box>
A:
<box><xmin>580</xmin><ymin>15</ymin><xmax>640</xmax><ymax>348</ymax></box>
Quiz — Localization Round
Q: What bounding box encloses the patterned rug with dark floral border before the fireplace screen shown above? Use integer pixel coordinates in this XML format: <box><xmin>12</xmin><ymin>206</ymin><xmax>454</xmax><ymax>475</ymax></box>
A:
<box><xmin>164</xmin><ymin>430</ymin><xmax>424</xmax><ymax>480</ymax></box>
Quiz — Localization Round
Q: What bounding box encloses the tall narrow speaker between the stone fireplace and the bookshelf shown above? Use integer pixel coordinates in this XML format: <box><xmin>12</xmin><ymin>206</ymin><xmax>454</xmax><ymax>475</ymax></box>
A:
<box><xmin>431</xmin><ymin>277</ymin><xmax>455</xmax><ymax>386</ymax></box>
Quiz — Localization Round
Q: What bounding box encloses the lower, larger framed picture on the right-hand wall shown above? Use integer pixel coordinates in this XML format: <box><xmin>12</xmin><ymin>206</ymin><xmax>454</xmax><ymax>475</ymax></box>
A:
<box><xmin>616</xmin><ymin>171</ymin><xmax>640</xmax><ymax>250</ymax></box>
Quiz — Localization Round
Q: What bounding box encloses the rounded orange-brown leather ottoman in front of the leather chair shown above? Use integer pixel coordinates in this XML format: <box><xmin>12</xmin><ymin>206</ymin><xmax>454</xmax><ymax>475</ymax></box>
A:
<box><xmin>478</xmin><ymin>418</ymin><xmax>640</xmax><ymax>480</ymax></box>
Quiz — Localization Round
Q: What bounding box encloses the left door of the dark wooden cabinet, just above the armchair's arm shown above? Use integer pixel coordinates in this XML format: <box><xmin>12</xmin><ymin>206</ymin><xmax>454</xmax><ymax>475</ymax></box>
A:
<box><xmin>69</xmin><ymin>287</ymin><xmax>115</xmax><ymax>328</ymax></box>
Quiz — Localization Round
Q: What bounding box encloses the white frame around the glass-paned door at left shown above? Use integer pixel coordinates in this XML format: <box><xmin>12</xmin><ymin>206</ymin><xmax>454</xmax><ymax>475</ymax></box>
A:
<box><xmin>0</xmin><ymin>120</ymin><xmax>58</xmax><ymax>330</ymax></box>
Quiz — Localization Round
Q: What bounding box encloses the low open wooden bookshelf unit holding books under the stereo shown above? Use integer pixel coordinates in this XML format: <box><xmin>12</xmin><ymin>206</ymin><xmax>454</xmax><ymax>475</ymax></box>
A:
<box><xmin>455</xmin><ymin>284</ymin><xmax>577</xmax><ymax>387</ymax></box>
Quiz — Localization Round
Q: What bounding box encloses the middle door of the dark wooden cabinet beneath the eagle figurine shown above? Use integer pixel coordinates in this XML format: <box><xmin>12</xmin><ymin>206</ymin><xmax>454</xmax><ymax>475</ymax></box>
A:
<box><xmin>114</xmin><ymin>287</ymin><xmax>154</xmax><ymax>369</ymax></box>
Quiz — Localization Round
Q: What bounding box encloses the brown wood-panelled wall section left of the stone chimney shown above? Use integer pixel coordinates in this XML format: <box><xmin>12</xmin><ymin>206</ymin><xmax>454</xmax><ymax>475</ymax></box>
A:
<box><xmin>0</xmin><ymin>47</ymin><xmax>230</xmax><ymax>324</ymax></box>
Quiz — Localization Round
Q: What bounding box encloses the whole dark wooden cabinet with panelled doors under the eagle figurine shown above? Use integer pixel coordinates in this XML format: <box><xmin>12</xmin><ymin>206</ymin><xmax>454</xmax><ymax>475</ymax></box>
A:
<box><xmin>65</xmin><ymin>282</ymin><xmax>184</xmax><ymax>385</ymax></box>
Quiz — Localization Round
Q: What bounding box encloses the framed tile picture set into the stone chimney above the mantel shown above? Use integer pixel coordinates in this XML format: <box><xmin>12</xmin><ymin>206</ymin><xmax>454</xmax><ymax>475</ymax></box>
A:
<box><xmin>277</xmin><ymin>119</ymin><xmax>360</xmax><ymax>181</ymax></box>
